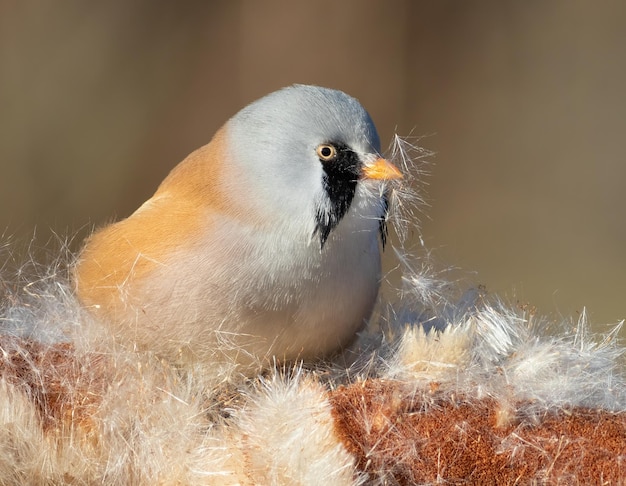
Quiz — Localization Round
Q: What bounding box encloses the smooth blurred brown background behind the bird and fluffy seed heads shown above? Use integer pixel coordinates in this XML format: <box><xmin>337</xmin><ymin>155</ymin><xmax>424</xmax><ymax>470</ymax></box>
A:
<box><xmin>0</xmin><ymin>0</ymin><xmax>626</xmax><ymax>323</ymax></box>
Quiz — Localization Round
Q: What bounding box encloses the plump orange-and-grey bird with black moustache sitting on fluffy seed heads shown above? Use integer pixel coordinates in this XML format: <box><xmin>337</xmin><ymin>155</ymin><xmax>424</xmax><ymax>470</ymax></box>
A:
<box><xmin>73</xmin><ymin>85</ymin><xmax>403</xmax><ymax>366</ymax></box>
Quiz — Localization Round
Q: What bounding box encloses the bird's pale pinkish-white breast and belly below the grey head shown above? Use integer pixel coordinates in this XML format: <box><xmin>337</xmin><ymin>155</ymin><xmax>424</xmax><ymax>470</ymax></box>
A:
<box><xmin>135</xmin><ymin>210</ymin><xmax>380</xmax><ymax>359</ymax></box>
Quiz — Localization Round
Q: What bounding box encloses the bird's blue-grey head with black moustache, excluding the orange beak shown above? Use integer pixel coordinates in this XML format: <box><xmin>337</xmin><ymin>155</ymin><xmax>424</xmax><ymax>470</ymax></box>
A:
<box><xmin>227</xmin><ymin>85</ymin><xmax>384</xmax><ymax>246</ymax></box>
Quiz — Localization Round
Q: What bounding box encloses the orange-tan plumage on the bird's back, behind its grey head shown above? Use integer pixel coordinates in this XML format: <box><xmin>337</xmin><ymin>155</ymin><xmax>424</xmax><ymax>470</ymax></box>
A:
<box><xmin>74</xmin><ymin>128</ymin><xmax>226</xmax><ymax>336</ymax></box>
